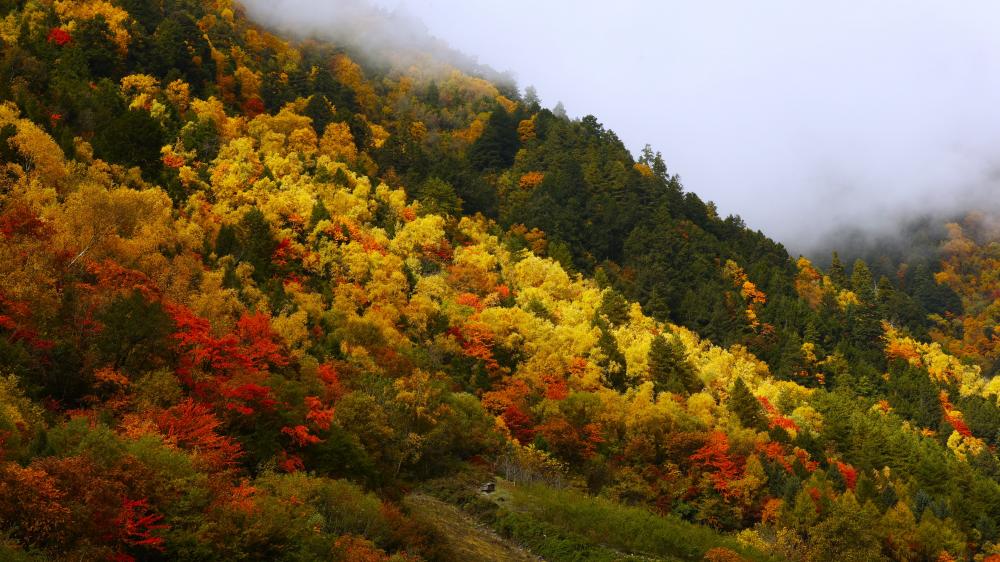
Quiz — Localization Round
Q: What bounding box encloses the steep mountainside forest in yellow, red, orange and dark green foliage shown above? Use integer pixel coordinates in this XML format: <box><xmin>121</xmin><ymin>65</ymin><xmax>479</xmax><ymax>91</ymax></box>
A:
<box><xmin>0</xmin><ymin>0</ymin><xmax>1000</xmax><ymax>562</ymax></box>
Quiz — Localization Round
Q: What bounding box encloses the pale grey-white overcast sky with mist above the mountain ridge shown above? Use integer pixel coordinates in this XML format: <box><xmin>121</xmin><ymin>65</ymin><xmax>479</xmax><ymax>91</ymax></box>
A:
<box><xmin>242</xmin><ymin>0</ymin><xmax>1000</xmax><ymax>250</ymax></box>
